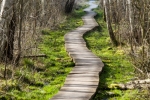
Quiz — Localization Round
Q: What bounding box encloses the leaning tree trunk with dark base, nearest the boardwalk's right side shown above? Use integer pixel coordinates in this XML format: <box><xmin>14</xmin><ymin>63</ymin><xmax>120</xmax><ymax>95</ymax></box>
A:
<box><xmin>104</xmin><ymin>0</ymin><xmax>118</xmax><ymax>46</ymax></box>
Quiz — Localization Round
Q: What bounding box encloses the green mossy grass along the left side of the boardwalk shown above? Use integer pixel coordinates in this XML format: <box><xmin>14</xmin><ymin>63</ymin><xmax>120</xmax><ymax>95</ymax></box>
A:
<box><xmin>0</xmin><ymin>9</ymin><xmax>84</xmax><ymax>100</ymax></box>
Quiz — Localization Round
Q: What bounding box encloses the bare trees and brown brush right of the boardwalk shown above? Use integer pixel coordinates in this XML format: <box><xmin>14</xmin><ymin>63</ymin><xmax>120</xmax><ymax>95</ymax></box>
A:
<box><xmin>100</xmin><ymin>0</ymin><xmax>150</xmax><ymax>77</ymax></box>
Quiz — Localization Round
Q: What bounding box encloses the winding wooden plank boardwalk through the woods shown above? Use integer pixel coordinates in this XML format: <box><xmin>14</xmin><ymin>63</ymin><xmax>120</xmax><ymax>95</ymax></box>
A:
<box><xmin>50</xmin><ymin>1</ymin><xmax>104</xmax><ymax>100</ymax></box>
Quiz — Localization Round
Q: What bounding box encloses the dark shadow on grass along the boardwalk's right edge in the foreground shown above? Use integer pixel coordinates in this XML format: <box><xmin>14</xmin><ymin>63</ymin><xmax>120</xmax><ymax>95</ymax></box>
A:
<box><xmin>93</xmin><ymin>62</ymin><xmax>120</xmax><ymax>100</ymax></box>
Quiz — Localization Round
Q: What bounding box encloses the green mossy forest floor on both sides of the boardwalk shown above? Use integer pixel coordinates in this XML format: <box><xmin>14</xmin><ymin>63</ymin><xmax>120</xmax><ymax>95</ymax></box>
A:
<box><xmin>0</xmin><ymin>1</ymin><xmax>149</xmax><ymax>100</ymax></box>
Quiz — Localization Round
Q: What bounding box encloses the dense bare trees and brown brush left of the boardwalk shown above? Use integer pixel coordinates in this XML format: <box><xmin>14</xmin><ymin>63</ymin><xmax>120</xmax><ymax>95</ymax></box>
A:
<box><xmin>0</xmin><ymin>0</ymin><xmax>75</xmax><ymax>64</ymax></box>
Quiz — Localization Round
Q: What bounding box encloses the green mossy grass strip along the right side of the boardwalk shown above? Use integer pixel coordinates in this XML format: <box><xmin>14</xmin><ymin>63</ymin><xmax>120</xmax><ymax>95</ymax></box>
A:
<box><xmin>85</xmin><ymin>9</ymin><xmax>137</xmax><ymax>100</ymax></box>
